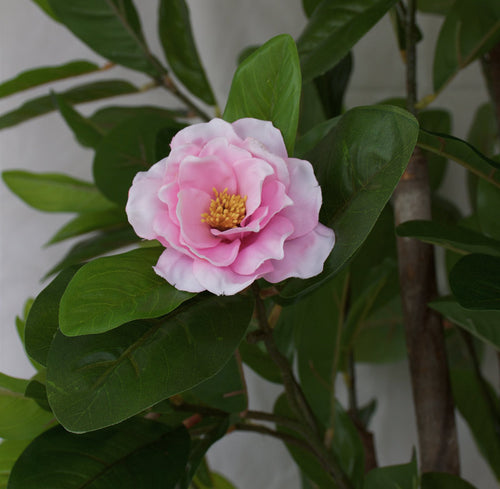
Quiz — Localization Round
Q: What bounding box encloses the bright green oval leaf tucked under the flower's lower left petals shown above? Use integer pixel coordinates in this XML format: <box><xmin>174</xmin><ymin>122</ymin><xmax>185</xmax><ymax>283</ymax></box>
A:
<box><xmin>59</xmin><ymin>247</ymin><xmax>193</xmax><ymax>336</ymax></box>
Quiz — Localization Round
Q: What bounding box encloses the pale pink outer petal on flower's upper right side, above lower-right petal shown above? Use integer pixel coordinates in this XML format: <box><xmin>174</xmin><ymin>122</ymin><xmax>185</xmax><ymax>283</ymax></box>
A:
<box><xmin>280</xmin><ymin>158</ymin><xmax>322</xmax><ymax>239</ymax></box>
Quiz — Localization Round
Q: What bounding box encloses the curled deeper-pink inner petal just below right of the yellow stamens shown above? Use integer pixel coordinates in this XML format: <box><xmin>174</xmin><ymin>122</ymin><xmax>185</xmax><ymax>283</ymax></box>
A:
<box><xmin>231</xmin><ymin>216</ymin><xmax>293</xmax><ymax>275</ymax></box>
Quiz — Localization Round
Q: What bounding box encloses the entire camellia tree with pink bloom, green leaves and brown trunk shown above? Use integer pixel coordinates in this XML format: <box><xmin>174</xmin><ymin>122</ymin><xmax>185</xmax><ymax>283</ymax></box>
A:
<box><xmin>0</xmin><ymin>0</ymin><xmax>500</xmax><ymax>489</ymax></box>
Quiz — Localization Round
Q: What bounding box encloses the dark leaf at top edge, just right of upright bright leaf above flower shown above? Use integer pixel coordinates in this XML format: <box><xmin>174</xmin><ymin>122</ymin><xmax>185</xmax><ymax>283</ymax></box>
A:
<box><xmin>297</xmin><ymin>0</ymin><xmax>397</xmax><ymax>82</ymax></box>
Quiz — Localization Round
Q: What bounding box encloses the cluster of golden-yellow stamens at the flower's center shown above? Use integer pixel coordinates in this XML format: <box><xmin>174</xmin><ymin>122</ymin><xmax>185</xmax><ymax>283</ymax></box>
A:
<box><xmin>201</xmin><ymin>188</ymin><xmax>247</xmax><ymax>231</ymax></box>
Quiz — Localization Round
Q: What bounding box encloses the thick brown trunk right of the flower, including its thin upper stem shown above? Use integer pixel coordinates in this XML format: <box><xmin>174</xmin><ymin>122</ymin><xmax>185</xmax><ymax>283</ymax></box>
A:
<box><xmin>393</xmin><ymin>0</ymin><xmax>459</xmax><ymax>474</ymax></box>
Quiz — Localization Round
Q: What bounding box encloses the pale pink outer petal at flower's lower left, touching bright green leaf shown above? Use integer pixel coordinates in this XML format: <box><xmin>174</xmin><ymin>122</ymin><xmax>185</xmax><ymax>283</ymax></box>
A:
<box><xmin>153</xmin><ymin>248</ymin><xmax>205</xmax><ymax>292</ymax></box>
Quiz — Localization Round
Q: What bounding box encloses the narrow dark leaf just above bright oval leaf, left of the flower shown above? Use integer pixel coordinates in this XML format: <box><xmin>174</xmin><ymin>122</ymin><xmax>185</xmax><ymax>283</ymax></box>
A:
<box><xmin>44</xmin><ymin>225</ymin><xmax>140</xmax><ymax>278</ymax></box>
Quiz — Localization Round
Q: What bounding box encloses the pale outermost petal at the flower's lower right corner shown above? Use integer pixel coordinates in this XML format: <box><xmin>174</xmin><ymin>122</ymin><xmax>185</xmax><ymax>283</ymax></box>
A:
<box><xmin>264</xmin><ymin>224</ymin><xmax>335</xmax><ymax>283</ymax></box>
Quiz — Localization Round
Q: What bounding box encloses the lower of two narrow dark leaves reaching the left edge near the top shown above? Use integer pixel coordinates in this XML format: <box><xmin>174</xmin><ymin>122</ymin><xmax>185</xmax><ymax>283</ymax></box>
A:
<box><xmin>0</xmin><ymin>80</ymin><xmax>138</xmax><ymax>130</ymax></box>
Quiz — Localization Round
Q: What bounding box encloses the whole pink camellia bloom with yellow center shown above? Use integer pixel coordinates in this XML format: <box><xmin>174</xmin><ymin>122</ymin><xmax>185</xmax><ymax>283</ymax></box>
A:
<box><xmin>126</xmin><ymin>119</ymin><xmax>335</xmax><ymax>295</ymax></box>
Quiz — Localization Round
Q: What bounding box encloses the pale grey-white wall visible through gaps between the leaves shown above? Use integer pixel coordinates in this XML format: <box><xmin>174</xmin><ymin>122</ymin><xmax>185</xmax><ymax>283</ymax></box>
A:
<box><xmin>0</xmin><ymin>0</ymin><xmax>498</xmax><ymax>489</ymax></box>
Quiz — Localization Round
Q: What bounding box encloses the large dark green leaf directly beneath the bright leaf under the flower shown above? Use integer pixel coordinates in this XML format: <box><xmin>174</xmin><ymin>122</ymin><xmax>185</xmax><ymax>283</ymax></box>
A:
<box><xmin>47</xmin><ymin>296</ymin><xmax>253</xmax><ymax>432</ymax></box>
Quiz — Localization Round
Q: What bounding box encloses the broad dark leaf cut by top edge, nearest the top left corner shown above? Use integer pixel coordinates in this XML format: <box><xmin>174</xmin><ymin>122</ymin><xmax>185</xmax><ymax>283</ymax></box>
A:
<box><xmin>48</xmin><ymin>0</ymin><xmax>165</xmax><ymax>77</ymax></box>
